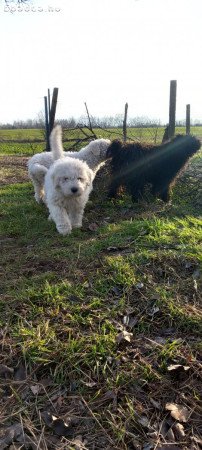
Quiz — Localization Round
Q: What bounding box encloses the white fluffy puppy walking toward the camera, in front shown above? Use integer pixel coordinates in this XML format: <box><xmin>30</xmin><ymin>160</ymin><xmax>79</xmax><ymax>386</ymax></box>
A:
<box><xmin>44</xmin><ymin>157</ymin><xmax>94</xmax><ymax>235</ymax></box>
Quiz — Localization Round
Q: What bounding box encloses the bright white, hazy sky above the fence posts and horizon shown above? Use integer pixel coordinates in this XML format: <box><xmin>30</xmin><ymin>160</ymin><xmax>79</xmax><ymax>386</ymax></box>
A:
<box><xmin>0</xmin><ymin>0</ymin><xmax>202</xmax><ymax>123</ymax></box>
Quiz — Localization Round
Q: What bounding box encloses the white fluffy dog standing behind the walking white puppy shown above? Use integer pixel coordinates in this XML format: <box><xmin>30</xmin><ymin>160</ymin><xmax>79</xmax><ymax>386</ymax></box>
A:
<box><xmin>28</xmin><ymin>125</ymin><xmax>110</xmax><ymax>203</ymax></box>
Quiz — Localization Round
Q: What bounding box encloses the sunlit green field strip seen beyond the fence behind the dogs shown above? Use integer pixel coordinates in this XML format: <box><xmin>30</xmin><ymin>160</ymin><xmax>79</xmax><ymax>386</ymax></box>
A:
<box><xmin>0</xmin><ymin>122</ymin><xmax>202</xmax><ymax>156</ymax></box>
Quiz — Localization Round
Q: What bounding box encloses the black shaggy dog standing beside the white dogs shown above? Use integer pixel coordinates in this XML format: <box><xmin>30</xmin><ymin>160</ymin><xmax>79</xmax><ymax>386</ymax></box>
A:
<box><xmin>107</xmin><ymin>135</ymin><xmax>201</xmax><ymax>202</ymax></box>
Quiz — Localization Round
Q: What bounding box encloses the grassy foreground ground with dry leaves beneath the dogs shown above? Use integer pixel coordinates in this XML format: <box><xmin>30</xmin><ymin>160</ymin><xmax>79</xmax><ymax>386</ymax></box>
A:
<box><xmin>0</xmin><ymin>134</ymin><xmax>202</xmax><ymax>450</ymax></box>
